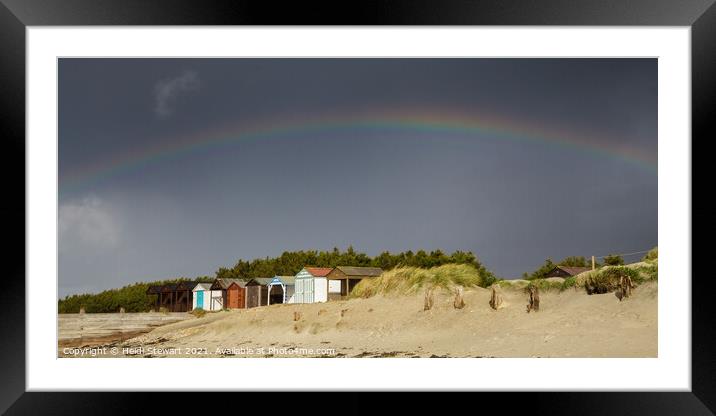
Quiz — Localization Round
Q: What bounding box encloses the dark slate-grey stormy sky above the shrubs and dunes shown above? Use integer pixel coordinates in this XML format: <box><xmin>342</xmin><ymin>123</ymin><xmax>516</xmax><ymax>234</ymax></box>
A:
<box><xmin>59</xmin><ymin>59</ymin><xmax>657</xmax><ymax>296</ymax></box>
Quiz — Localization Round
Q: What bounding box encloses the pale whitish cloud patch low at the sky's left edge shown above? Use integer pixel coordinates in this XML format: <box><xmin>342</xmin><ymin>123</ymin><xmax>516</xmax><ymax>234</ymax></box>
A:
<box><xmin>58</xmin><ymin>197</ymin><xmax>120</xmax><ymax>252</ymax></box>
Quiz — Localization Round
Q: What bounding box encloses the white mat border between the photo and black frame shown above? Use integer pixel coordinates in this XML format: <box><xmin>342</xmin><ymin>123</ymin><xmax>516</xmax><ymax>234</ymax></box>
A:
<box><xmin>26</xmin><ymin>27</ymin><xmax>691</xmax><ymax>391</ymax></box>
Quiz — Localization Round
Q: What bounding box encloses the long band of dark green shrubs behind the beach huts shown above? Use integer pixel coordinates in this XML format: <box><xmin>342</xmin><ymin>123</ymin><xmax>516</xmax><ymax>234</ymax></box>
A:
<box><xmin>58</xmin><ymin>247</ymin><xmax>497</xmax><ymax>313</ymax></box>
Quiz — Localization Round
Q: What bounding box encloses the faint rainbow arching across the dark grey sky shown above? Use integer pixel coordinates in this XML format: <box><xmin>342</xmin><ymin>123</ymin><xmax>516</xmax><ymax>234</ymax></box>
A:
<box><xmin>61</xmin><ymin>110</ymin><xmax>657</xmax><ymax>189</ymax></box>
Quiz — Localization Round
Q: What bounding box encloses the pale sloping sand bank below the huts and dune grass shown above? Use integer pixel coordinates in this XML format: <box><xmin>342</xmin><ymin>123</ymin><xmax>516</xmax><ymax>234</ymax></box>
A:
<box><xmin>86</xmin><ymin>282</ymin><xmax>657</xmax><ymax>357</ymax></box>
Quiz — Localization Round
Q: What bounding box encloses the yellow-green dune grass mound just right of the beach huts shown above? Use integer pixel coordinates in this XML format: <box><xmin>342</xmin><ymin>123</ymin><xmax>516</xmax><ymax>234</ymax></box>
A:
<box><xmin>351</xmin><ymin>264</ymin><xmax>484</xmax><ymax>298</ymax></box>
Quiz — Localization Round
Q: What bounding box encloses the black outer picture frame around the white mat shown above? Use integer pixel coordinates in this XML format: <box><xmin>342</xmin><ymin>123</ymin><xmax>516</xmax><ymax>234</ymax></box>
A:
<box><xmin>0</xmin><ymin>0</ymin><xmax>716</xmax><ymax>415</ymax></box>
